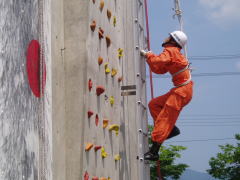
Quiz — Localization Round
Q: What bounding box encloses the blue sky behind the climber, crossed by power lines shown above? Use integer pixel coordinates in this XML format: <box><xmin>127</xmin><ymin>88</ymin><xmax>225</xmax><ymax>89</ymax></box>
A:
<box><xmin>148</xmin><ymin>0</ymin><xmax>240</xmax><ymax>172</ymax></box>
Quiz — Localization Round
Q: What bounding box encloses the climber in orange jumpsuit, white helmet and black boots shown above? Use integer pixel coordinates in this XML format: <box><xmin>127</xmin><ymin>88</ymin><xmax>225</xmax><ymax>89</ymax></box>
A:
<box><xmin>140</xmin><ymin>31</ymin><xmax>193</xmax><ymax>161</ymax></box>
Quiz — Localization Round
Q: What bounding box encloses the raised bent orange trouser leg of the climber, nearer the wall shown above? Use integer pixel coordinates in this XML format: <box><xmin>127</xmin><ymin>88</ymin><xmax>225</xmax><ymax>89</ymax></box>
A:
<box><xmin>148</xmin><ymin>92</ymin><xmax>170</xmax><ymax>124</ymax></box>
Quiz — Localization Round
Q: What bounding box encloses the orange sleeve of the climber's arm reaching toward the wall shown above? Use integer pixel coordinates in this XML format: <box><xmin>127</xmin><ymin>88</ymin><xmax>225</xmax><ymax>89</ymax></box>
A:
<box><xmin>147</xmin><ymin>49</ymin><xmax>171</xmax><ymax>74</ymax></box>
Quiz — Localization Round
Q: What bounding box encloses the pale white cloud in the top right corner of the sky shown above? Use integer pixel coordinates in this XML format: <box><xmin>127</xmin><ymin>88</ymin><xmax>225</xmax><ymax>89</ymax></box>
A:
<box><xmin>198</xmin><ymin>0</ymin><xmax>240</xmax><ymax>24</ymax></box>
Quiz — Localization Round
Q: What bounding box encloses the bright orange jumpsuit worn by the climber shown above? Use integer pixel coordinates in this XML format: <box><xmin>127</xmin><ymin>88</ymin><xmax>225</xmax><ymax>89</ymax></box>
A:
<box><xmin>147</xmin><ymin>45</ymin><xmax>193</xmax><ymax>143</ymax></box>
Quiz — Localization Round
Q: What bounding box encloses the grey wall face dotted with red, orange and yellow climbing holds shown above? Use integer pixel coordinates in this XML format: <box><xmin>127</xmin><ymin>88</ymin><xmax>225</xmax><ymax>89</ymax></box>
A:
<box><xmin>83</xmin><ymin>0</ymin><xmax>148</xmax><ymax>180</ymax></box>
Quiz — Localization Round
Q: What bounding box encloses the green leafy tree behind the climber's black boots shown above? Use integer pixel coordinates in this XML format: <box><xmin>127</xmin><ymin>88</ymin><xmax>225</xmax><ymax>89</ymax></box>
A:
<box><xmin>149</xmin><ymin>126</ymin><xmax>189</xmax><ymax>180</ymax></box>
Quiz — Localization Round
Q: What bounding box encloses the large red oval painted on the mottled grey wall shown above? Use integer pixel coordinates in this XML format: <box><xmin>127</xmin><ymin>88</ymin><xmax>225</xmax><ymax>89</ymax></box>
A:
<box><xmin>27</xmin><ymin>40</ymin><xmax>46</xmax><ymax>97</ymax></box>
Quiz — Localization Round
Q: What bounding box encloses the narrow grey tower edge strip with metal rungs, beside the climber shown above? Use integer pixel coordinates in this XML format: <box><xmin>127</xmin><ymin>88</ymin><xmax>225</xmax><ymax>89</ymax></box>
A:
<box><xmin>133</xmin><ymin>0</ymin><xmax>150</xmax><ymax>180</ymax></box>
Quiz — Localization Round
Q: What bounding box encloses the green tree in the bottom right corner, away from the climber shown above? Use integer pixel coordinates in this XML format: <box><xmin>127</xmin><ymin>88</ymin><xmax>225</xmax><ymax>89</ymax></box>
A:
<box><xmin>207</xmin><ymin>134</ymin><xmax>240</xmax><ymax>180</ymax></box>
